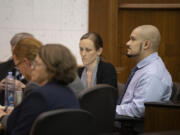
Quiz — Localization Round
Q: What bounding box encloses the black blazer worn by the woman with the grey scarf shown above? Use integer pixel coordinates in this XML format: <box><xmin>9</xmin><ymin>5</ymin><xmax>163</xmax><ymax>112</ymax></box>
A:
<box><xmin>78</xmin><ymin>60</ymin><xmax>117</xmax><ymax>88</ymax></box>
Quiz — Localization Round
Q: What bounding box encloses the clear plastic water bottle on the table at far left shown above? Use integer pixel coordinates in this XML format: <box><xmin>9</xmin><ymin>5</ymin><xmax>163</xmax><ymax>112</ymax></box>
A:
<box><xmin>5</xmin><ymin>72</ymin><xmax>15</xmax><ymax>107</ymax></box>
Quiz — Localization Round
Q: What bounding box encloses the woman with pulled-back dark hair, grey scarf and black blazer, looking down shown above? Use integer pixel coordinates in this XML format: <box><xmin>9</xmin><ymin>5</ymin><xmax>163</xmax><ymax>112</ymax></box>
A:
<box><xmin>78</xmin><ymin>32</ymin><xmax>117</xmax><ymax>88</ymax></box>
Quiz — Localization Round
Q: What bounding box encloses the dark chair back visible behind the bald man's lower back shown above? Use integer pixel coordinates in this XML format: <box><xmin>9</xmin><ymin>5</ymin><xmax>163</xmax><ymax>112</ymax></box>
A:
<box><xmin>170</xmin><ymin>82</ymin><xmax>180</xmax><ymax>102</ymax></box>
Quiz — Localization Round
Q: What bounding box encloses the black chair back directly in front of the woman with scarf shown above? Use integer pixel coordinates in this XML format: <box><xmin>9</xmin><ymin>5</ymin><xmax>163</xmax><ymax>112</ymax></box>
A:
<box><xmin>79</xmin><ymin>84</ymin><xmax>117</xmax><ymax>133</ymax></box>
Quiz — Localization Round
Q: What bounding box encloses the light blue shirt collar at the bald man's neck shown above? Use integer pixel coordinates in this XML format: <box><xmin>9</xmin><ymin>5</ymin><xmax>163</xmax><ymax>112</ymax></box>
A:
<box><xmin>137</xmin><ymin>52</ymin><xmax>159</xmax><ymax>69</ymax></box>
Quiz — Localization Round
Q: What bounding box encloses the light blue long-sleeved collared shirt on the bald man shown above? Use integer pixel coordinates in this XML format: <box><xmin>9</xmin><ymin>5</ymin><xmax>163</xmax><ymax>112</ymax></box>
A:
<box><xmin>116</xmin><ymin>53</ymin><xmax>172</xmax><ymax>117</ymax></box>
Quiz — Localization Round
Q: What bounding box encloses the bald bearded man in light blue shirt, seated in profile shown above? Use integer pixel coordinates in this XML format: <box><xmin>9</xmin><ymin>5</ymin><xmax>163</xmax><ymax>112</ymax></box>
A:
<box><xmin>116</xmin><ymin>25</ymin><xmax>172</xmax><ymax>117</ymax></box>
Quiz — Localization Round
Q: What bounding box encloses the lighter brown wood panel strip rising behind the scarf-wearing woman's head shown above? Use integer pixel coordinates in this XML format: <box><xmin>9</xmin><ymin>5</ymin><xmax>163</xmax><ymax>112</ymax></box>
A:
<box><xmin>89</xmin><ymin>0</ymin><xmax>118</xmax><ymax>62</ymax></box>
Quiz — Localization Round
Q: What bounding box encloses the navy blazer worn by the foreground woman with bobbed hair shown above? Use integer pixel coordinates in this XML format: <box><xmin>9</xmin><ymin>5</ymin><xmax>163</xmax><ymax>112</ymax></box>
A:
<box><xmin>5</xmin><ymin>82</ymin><xmax>79</xmax><ymax>135</ymax></box>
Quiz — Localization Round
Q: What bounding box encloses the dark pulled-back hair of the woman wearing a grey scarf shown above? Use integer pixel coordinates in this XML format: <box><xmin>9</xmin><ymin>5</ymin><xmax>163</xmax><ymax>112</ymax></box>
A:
<box><xmin>80</xmin><ymin>32</ymin><xmax>103</xmax><ymax>50</ymax></box>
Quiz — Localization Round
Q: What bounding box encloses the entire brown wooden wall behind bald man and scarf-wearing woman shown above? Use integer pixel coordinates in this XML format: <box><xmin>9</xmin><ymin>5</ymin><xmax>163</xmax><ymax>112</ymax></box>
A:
<box><xmin>89</xmin><ymin>0</ymin><xmax>180</xmax><ymax>83</ymax></box>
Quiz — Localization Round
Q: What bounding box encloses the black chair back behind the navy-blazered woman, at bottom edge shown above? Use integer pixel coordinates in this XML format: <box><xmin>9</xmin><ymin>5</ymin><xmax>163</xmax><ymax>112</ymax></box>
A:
<box><xmin>30</xmin><ymin>109</ymin><xmax>95</xmax><ymax>135</ymax></box>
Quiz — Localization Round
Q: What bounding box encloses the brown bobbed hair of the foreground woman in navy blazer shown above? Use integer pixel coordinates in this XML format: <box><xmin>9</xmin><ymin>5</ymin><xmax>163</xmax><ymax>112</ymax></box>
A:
<box><xmin>39</xmin><ymin>44</ymin><xmax>77</xmax><ymax>85</ymax></box>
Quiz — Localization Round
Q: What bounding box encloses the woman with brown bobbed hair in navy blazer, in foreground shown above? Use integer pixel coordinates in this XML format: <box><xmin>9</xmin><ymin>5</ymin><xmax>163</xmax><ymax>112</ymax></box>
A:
<box><xmin>5</xmin><ymin>44</ymin><xmax>79</xmax><ymax>135</ymax></box>
